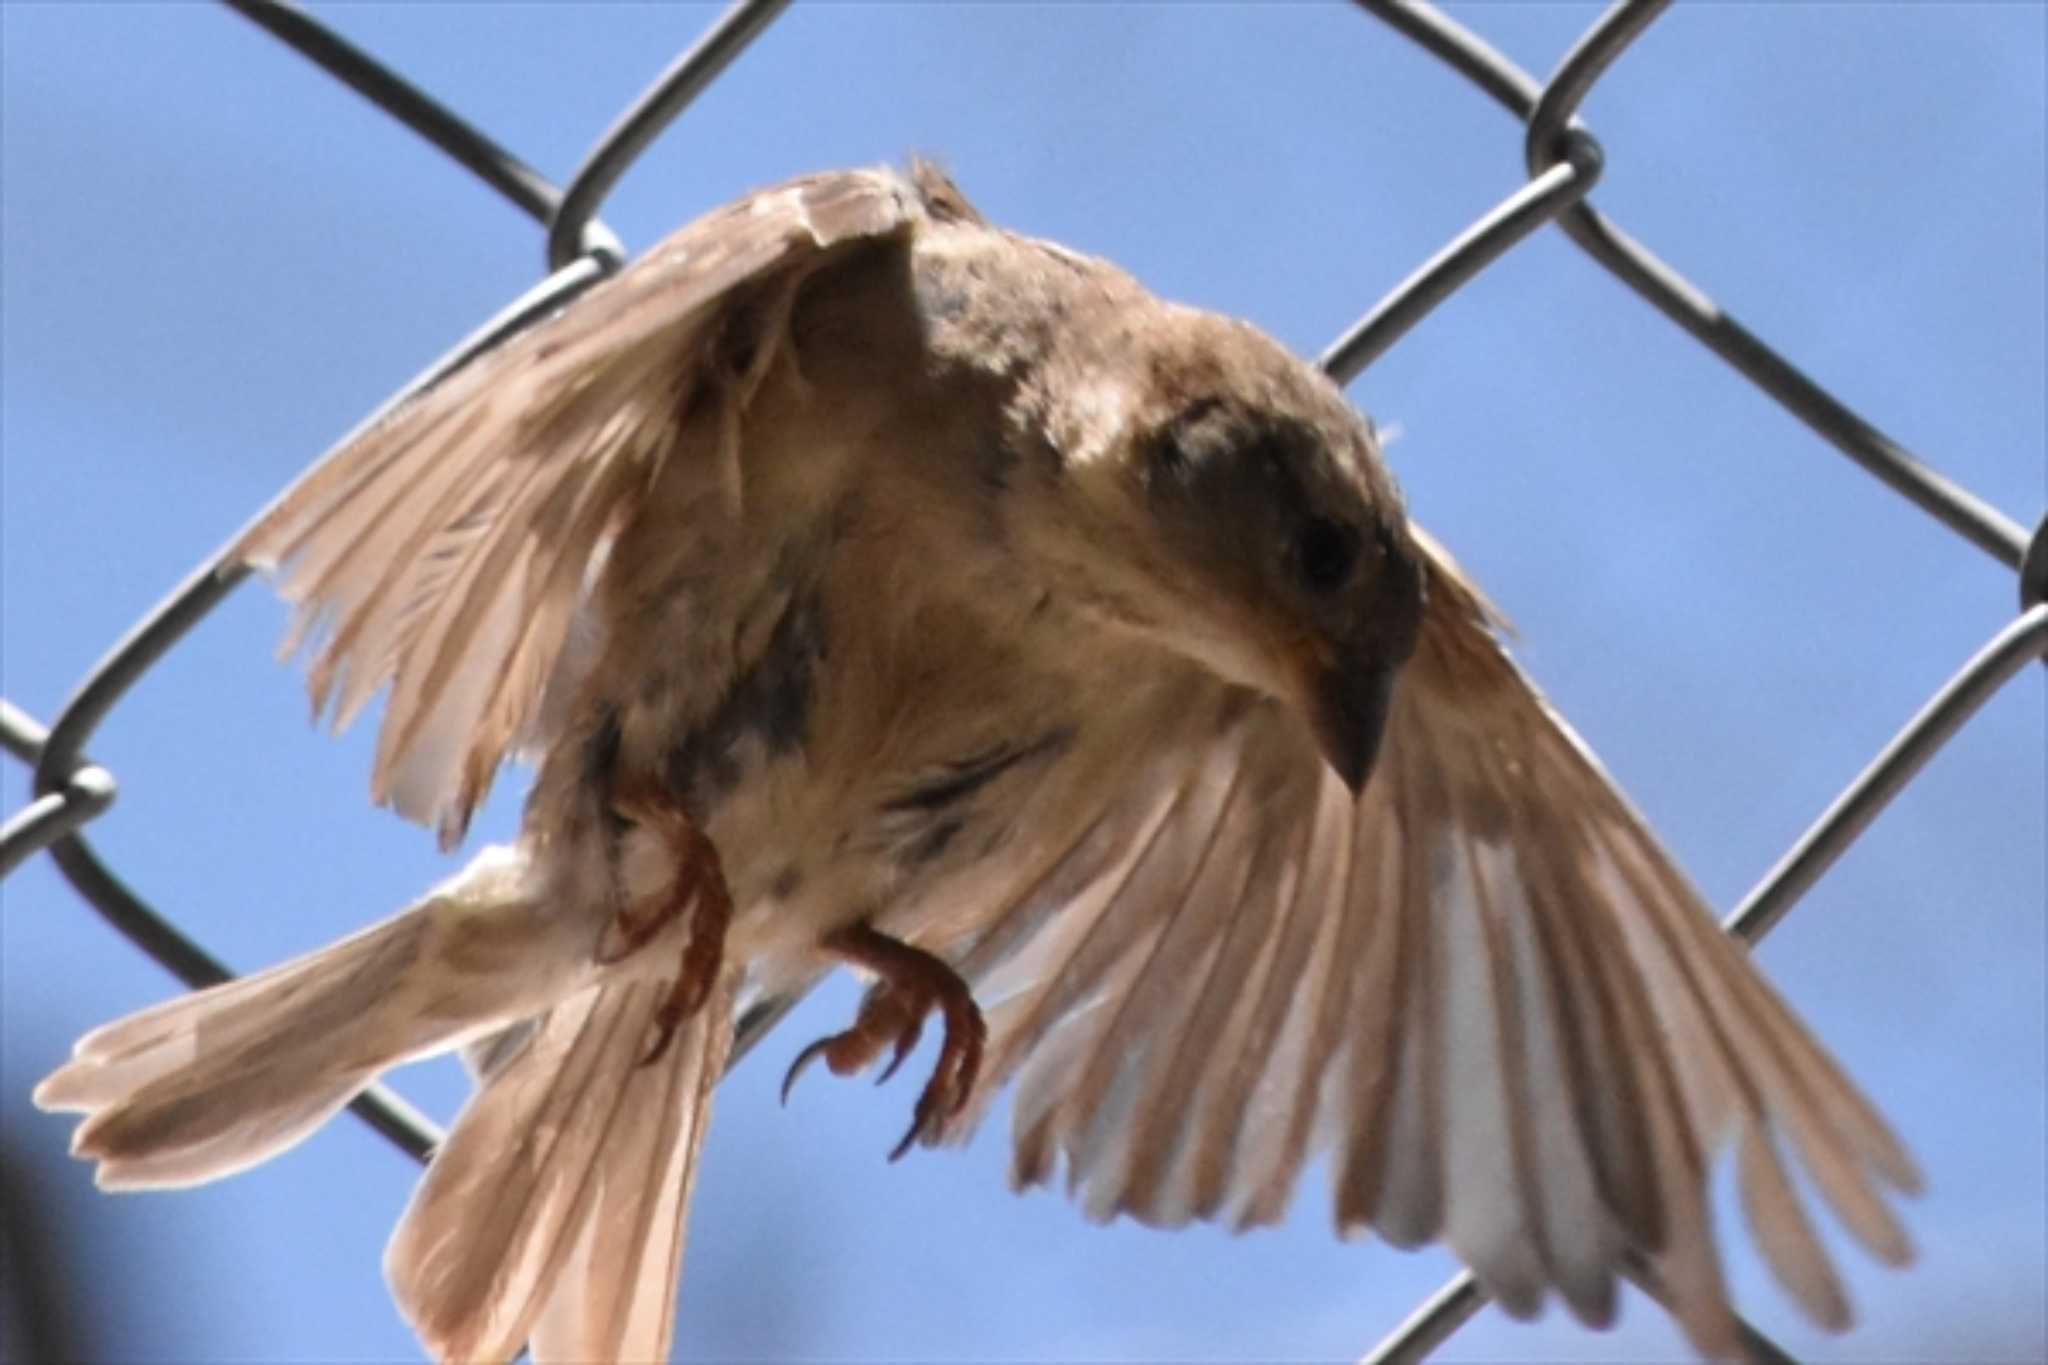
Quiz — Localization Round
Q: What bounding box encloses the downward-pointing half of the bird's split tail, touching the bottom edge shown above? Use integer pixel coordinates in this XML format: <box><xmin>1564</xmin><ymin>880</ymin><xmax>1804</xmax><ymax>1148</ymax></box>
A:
<box><xmin>385</xmin><ymin>980</ymin><xmax>733</xmax><ymax>1365</ymax></box>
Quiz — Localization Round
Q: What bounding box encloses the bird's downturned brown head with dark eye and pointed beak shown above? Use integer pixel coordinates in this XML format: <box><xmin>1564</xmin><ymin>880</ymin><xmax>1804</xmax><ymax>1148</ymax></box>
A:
<box><xmin>1007</xmin><ymin>301</ymin><xmax>1423</xmax><ymax>792</ymax></box>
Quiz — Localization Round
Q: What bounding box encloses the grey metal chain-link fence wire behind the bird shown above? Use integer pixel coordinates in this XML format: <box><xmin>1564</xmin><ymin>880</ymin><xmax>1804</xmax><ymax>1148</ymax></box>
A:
<box><xmin>0</xmin><ymin>0</ymin><xmax>2048</xmax><ymax>1361</ymax></box>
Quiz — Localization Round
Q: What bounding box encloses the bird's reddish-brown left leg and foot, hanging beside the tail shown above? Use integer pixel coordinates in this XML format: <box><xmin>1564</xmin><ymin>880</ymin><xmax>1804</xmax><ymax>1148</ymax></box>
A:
<box><xmin>598</xmin><ymin>794</ymin><xmax>733</xmax><ymax>1066</ymax></box>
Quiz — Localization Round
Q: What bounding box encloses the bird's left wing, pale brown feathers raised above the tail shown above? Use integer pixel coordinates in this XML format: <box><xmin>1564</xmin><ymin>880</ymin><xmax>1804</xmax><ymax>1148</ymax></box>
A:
<box><xmin>233</xmin><ymin>170</ymin><xmax>929</xmax><ymax>845</ymax></box>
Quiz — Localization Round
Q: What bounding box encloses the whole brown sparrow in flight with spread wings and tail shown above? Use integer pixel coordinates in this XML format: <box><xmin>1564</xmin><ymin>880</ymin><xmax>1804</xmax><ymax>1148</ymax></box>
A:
<box><xmin>35</xmin><ymin>160</ymin><xmax>1921</xmax><ymax>1363</ymax></box>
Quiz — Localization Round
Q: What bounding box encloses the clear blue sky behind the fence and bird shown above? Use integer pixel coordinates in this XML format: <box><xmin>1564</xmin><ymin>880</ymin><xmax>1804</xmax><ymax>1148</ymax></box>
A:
<box><xmin>0</xmin><ymin>4</ymin><xmax>2048</xmax><ymax>1361</ymax></box>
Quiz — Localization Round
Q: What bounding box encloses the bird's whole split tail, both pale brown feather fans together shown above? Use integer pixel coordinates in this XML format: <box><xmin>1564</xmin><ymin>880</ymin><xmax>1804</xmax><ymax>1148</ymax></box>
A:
<box><xmin>35</xmin><ymin>849</ymin><xmax>737</xmax><ymax>1365</ymax></box>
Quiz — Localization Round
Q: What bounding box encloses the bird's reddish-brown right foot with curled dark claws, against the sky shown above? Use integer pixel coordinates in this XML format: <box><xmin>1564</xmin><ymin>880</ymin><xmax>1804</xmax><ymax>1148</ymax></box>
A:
<box><xmin>782</xmin><ymin>925</ymin><xmax>989</xmax><ymax>1160</ymax></box>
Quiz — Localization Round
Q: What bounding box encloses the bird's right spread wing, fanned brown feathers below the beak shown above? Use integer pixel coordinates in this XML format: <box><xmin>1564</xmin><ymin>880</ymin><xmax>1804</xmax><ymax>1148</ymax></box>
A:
<box><xmin>950</xmin><ymin>536</ymin><xmax>1919</xmax><ymax>1353</ymax></box>
